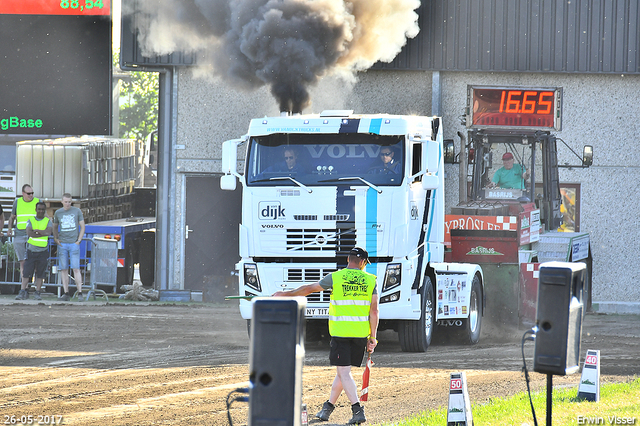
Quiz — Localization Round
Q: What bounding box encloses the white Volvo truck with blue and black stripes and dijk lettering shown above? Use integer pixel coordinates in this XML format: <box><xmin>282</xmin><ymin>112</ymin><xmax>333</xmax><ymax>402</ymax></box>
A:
<box><xmin>221</xmin><ymin>111</ymin><xmax>485</xmax><ymax>352</ymax></box>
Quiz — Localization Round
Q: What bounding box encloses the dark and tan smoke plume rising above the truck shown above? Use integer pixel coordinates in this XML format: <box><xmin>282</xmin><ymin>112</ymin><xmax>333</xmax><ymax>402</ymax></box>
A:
<box><xmin>123</xmin><ymin>0</ymin><xmax>420</xmax><ymax>112</ymax></box>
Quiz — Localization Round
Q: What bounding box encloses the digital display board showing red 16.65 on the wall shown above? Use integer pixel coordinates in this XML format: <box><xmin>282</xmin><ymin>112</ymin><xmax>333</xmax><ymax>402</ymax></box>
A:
<box><xmin>466</xmin><ymin>86</ymin><xmax>562</xmax><ymax>130</ymax></box>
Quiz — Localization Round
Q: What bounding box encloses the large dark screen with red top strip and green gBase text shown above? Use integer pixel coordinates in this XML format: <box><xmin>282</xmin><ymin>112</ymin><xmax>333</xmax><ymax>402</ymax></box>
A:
<box><xmin>0</xmin><ymin>0</ymin><xmax>112</xmax><ymax>135</ymax></box>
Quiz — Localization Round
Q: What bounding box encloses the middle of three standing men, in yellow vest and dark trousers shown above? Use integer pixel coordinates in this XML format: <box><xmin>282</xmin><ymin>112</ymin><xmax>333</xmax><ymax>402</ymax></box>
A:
<box><xmin>16</xmin><ymin>202</ymin><xmax>53</xmax><ymax>300</ymax></box>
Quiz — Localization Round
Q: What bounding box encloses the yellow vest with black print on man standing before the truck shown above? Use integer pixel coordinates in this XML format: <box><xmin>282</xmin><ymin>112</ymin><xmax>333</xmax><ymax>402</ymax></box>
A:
<box><xmin>329</xmin><ymin>269</ymin><xmax>376</xmax><ymax>337</ymax></box>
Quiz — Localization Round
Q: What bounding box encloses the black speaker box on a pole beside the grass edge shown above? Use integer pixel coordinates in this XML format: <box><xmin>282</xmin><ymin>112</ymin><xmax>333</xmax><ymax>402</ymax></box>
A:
<box><xmin>533</xmin><ymin>262</ymin><xmax>586</xmax><ymax>376</ymax></box>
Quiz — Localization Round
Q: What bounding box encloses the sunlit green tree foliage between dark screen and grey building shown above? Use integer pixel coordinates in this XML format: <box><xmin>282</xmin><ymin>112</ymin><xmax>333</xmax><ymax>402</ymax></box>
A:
<box><xmin>114</xmin><ymin>52</ymin><xmax>159</xmax><ymax>140</ymax></box>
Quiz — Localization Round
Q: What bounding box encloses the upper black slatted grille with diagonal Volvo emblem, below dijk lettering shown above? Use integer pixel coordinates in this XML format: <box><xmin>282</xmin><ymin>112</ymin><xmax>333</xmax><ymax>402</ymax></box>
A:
<box><xmin>286</xmin><ymin>228</ymin><xmax>356</xmax><ymax>251</ymax></box>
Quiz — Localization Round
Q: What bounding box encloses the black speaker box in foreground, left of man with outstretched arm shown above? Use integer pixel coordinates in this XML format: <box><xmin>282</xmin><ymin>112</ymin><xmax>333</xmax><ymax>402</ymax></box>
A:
<box><xmin>249</xmin><ymin>297</ymin><xmax>306</xmax><ymax>426</ymax></box>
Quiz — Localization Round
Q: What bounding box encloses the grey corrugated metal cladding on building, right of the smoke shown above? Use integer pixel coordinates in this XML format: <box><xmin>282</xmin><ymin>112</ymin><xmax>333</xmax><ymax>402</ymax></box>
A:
<box><xmin>375</xmin><ymin>0</ymin><xmax>640</xmax><ymax>74</ymax></box>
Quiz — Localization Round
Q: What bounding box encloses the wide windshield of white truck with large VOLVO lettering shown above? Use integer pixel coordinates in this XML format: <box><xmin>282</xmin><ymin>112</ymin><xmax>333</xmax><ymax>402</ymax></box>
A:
<box><xmin>246</xmin><ymin>133</ymin><xmax>405</xmax><ymax>186</ymax></box>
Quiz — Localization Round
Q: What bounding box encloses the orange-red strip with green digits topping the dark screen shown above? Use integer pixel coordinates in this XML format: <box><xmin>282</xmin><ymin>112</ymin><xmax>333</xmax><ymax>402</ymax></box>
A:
<box><xmin>0</xmin><ymin>0</ymin><xmax>111</xmax><ymax>16</ymax></box>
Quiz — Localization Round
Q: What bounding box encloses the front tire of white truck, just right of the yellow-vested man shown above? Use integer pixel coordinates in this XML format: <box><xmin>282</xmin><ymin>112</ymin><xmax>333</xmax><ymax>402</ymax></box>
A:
<box><xmin>398</xmin><ymin>277</ymin><xmax>435</xmax><ymax>352</ymax></box>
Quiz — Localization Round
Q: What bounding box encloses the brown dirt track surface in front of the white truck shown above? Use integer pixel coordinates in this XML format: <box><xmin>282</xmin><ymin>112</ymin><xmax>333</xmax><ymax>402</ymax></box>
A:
<box><xmin>0</xmin><ymin>298</ymin><xmax>640</xmax><ymax>426</ymax></box>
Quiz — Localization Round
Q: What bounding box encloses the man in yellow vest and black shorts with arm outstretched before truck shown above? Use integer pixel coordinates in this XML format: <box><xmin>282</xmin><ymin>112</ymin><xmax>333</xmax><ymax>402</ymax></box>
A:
<box><xmin>274</xmin><ymin>247</ymin><xmax>379</xmax><ymax>424</ymax></box>
